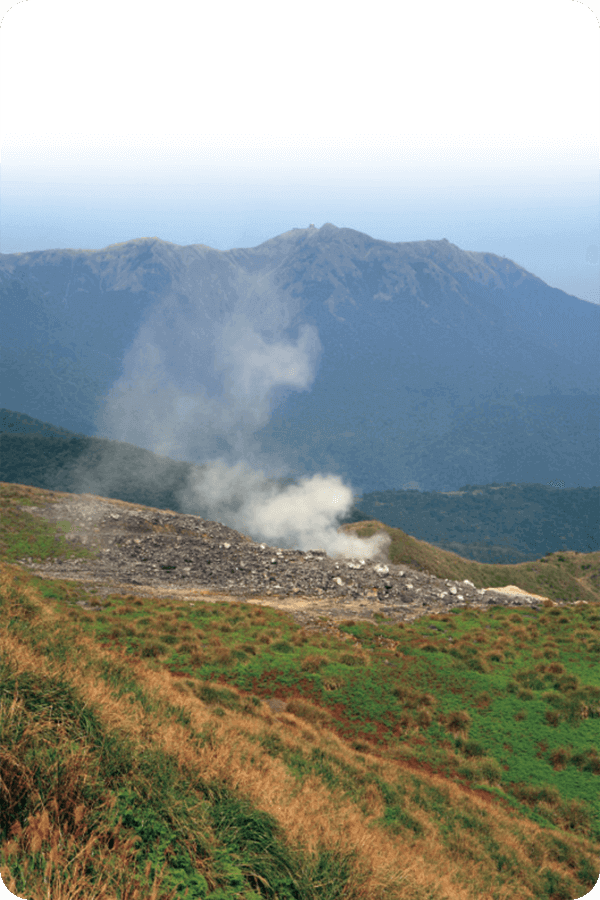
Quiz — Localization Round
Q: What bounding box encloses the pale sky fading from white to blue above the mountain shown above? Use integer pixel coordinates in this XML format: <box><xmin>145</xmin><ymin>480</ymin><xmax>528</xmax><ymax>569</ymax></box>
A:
<box><xmin>0</xmin><ymin>0</ymin><xmax>600</xmax><ymax>302</ymax></box>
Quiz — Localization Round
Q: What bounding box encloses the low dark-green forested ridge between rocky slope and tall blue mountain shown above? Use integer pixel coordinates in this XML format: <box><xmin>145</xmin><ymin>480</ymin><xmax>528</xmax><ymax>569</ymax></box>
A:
<box><xmin>0</xmin><ymin>409</ymin><xmax>600</xmax><ymax>565</ymax></box>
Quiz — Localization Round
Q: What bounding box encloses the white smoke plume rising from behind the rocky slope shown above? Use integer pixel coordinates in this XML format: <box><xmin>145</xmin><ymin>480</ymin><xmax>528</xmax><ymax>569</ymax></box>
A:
<box><xmin>76</xmin><ymin>268</ymin><xmax>389</xmax><ymax>559</ymax></box>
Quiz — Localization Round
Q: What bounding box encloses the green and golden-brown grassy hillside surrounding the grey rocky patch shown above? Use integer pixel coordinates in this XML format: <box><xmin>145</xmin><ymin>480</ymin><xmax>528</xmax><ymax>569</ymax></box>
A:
<box><xmin>0</xmin><ymin>485</ymin><xmax>600</xmax><ymax>900</ymax></box>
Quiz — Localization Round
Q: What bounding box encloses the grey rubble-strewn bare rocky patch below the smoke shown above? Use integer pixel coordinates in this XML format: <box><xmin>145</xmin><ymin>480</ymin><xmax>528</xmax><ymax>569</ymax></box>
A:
<box><xmin>5</xmin><ymin>494</ymin><xmax>564</xmax><ymax>623</ymax></box>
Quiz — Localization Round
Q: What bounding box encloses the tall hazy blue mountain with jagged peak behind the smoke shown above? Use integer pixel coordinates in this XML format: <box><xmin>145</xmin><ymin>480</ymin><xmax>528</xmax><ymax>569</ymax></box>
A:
<box><xmin>0</xmin><ymin>223</ymin><xmax>600</xmax><ymax>493</ymax></box>
